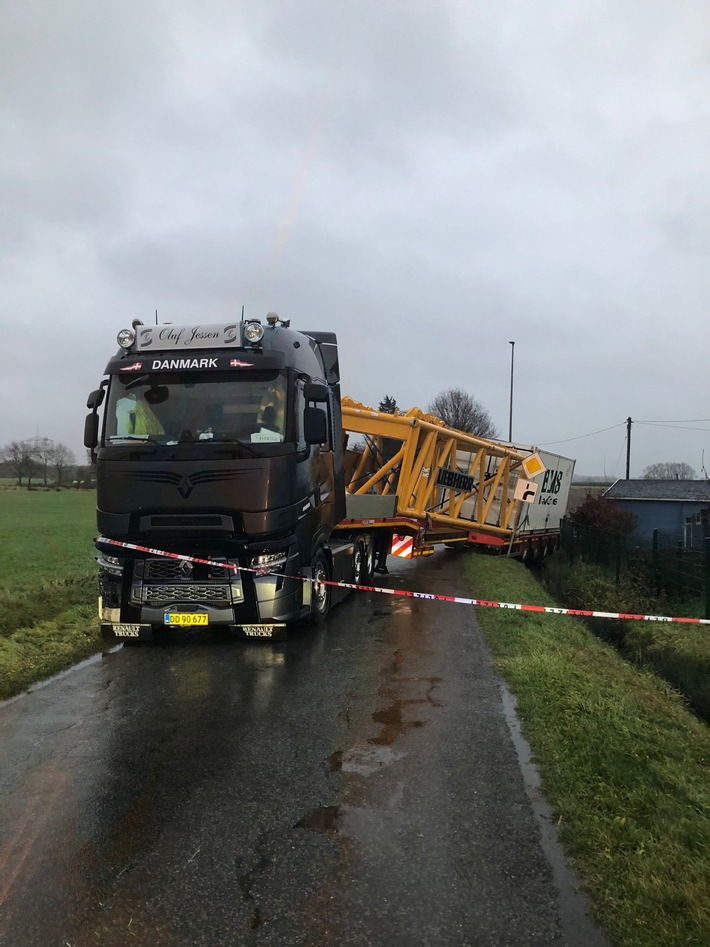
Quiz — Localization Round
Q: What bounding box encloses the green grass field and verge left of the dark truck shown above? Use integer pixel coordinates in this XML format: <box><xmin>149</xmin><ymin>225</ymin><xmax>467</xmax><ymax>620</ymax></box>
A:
<box><xmin>0</xmin><ymin>490</ymin><xmax>101</xmax><ymax>699</ymax></box>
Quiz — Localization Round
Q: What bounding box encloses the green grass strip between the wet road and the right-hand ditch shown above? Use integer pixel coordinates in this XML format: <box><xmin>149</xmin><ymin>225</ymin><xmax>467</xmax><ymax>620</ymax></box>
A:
<box><xmin>466</xmin><ymin>555</ymin><xmax>710</xmax><ymax>947</ymax></box>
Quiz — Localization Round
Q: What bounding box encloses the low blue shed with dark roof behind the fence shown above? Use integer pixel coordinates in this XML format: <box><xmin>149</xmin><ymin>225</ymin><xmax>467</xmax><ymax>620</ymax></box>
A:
<box><xmin>604</xmin><ymin>480</ymin><xmax>710</xmax><ymax>549</ymax></box>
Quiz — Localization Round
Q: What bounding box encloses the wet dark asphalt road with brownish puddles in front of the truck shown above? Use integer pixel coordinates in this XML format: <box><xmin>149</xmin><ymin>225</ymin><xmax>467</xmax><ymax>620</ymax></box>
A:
<box><xmin>0</xmin><ymin>552</ymin><xmax>605</xmax><ymax>947</ymax></box>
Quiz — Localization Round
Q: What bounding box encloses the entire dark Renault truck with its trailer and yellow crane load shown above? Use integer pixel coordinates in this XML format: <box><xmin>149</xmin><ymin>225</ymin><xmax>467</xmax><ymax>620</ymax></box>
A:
<box><xmin>84</xmin><ymin>313</ymin><xmax>574</xmax><ymax>642</ymax></box>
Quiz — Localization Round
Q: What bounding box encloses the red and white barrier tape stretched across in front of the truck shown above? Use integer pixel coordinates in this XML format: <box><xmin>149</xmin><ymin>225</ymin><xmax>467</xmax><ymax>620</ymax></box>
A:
<box><xmin>100</xmin><ymin>536</ymin><xmax>710</xmax><ymax>625</ymax></box>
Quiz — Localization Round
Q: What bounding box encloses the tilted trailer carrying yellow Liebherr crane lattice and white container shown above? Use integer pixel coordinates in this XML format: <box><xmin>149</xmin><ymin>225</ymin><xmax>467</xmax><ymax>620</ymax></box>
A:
<box><xmin>337</xmin><ymin>398</ymin><xmax>574</xmax><ymax>559</ymax></box>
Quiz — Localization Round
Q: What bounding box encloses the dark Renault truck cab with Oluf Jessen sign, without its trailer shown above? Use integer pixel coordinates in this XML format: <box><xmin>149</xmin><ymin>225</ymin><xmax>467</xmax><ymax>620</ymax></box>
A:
<box><xmin>85</xmin><ymin>314</ymin><xmax>345</xmax><ymax>640</ymax></box>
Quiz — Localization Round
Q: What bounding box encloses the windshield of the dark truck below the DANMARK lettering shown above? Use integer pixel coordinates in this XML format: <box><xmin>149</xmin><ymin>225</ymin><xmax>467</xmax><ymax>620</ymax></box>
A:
<box><xmin>104</xmin><ymin>371</ymin><xmax>286</xmax><ymax>444</ymax></box>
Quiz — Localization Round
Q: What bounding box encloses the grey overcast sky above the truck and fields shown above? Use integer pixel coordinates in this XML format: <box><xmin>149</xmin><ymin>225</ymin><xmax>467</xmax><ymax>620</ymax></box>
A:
<box><xmin>0</xmin><ymin>0</ymin><xmax>710</xmax><ymax>478</ymax></box>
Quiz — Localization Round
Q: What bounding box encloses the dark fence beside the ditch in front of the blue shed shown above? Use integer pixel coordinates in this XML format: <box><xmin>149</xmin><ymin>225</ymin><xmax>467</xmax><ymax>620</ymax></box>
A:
<box><xmin>560</xmin><ymin>519</ymin><xmax>710</xmax><ymax>618</ymax></box>
